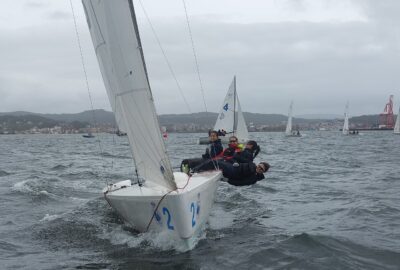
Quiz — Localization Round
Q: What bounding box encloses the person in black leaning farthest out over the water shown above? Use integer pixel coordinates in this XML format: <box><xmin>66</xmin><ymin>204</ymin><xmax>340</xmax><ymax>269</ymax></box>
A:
<box><xmin>218</xmin><ymin>161</ymin><xmax>270</xmax><ymax>186</ymax></box>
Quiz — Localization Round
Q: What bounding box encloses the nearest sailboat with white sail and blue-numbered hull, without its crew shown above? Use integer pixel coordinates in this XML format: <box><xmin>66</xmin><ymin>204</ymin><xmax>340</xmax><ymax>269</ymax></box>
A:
<box><xmin>83</xmin><ymin>0</ymin><xmax>221</xmax><ymax>249</ymax></box>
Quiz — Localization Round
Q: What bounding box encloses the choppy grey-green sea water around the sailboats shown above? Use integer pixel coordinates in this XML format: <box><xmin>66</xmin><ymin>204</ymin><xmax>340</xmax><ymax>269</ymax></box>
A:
<box><xmin>0</xmin><ymin>131</ymin><xmax>400</xmax><ymax>269</ymax></box>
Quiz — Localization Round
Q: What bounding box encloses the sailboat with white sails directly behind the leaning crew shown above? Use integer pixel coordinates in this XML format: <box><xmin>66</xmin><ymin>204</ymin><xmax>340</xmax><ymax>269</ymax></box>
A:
<box><xmin>199</xmin><ymin>76</ymin><xmax>249</xmax><ymax>144</ymax></box>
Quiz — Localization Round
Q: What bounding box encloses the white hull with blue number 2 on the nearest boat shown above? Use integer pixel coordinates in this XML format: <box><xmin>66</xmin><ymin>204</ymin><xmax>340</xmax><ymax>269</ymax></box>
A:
<box><xmin>104</xmin><ymin>171</ymin><xmax>222</xmax><ymax>248</ymax></box>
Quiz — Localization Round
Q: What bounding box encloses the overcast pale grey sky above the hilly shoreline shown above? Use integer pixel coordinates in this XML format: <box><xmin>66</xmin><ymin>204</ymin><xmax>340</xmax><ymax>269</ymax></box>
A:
<box><xmin>0</xmin><ymin>0</ymin><xmax>400</xmax><ymax>115</ymax></box>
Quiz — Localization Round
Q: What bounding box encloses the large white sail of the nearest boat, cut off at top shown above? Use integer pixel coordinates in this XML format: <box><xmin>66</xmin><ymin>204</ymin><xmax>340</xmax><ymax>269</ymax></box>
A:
<box><xmin>83</xmin><ymin>0</ymin><xmax>176</xmax><ymax>190</ymax></box>
